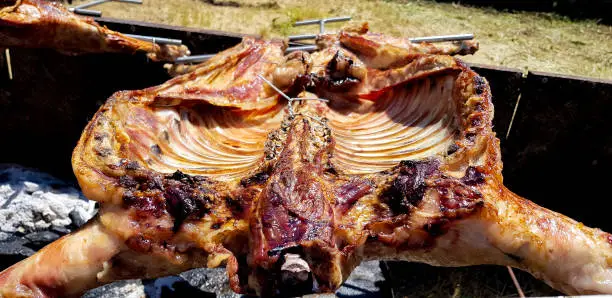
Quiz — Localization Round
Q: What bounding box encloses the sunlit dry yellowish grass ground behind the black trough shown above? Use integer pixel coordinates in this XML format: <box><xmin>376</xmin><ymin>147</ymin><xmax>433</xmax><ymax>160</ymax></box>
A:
<box><xmin>74</xmin><ymin>0</ymin><xmax>612</xmax><ymax>79</ymax></box>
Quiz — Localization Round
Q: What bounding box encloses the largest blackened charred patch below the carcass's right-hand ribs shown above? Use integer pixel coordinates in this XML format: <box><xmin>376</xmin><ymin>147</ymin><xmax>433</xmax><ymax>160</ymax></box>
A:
<box><xmin>382</xmin><ymin>160</ymin><xmax>439</xmax><ymax>215</ymax></box>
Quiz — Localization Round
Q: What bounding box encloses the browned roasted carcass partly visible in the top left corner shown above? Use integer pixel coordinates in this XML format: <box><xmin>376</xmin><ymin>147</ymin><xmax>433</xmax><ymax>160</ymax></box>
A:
<box><xmin>0</xmin><ymin>0</ymin><xmax>189</xmax><ymax>61</ymax></box>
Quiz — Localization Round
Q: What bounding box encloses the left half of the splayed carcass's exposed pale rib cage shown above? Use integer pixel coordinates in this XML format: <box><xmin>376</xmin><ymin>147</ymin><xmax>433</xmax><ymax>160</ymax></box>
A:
<box><xmin>123</xmin><ymin>106</ymin><xmax>284</xmax><ymax>180</ymax></box>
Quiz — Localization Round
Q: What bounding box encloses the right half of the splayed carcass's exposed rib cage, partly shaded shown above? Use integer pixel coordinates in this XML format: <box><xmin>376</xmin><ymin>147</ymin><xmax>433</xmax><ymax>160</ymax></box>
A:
<box><xmin>327</xmin><ymin>76</ymin><xmax>459</xmax><ymax>174</ymax></box>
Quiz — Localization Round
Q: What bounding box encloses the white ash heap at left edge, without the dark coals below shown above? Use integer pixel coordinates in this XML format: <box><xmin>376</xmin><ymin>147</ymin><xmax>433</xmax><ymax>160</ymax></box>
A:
<box><xmin>0</xmin><ymin>165</ymin><xmax>95</xmax><ymax>235</ymax></box>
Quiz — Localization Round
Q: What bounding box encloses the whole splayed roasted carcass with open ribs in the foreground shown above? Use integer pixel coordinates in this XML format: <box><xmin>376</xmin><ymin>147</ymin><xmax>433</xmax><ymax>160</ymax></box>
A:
<box><xmin>0</xmin><ymin>27</ymin><xmax>612</xmax><ymax>297</ymax></box>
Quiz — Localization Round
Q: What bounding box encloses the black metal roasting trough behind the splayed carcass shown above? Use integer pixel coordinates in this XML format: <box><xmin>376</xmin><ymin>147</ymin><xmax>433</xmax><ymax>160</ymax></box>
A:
<box><xmin>0</xmin><ymin>18</ymin><xmax>612</xmax><ymax>298</ymax></box>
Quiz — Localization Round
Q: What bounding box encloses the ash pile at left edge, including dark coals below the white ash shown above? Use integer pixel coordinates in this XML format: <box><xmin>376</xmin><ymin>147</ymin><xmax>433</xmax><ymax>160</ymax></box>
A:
<box><xmin>0</xmin><ymin>165</ymin><xmax>95</xmax><ymax>269</ymax></box>
